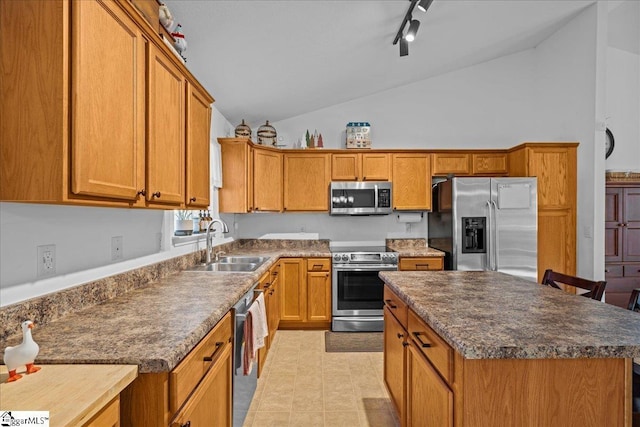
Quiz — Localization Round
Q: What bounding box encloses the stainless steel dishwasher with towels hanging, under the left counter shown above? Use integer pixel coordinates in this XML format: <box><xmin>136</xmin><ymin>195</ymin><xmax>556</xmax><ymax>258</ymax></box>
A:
<box><xmin>233</xmin><ymin>283</ymin><xmax>262</xmax><ymax>427</ymax></box>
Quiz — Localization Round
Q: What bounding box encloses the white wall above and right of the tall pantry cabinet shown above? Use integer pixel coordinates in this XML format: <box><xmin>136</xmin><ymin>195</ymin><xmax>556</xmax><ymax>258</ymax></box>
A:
<box><xmin>533</xmin><ymin>4</ymin><xmax>606</xmax><ymax>280</ymax></box>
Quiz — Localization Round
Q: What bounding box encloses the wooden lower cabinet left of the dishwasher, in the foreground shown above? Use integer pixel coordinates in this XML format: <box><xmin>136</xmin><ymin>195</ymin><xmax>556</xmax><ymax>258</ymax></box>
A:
<box><xmin>120</xmin><ymin>312</ymin><xmax>233</xmax><ymax>427</ymax></box>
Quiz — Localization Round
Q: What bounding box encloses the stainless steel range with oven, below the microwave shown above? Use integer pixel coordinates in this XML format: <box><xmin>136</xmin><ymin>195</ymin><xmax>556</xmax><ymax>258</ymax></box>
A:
<box><xmin>331</xmin><ymin>243</ymin><xmax>398</xmax><ymax>332</ymax></box>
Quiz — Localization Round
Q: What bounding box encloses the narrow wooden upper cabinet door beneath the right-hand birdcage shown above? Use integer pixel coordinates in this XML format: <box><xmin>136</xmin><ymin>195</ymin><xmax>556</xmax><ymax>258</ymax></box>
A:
<box><xmin>253</xmin><ymin>148</ymin><xmax>282</xmax><ymax>212</ymax></box>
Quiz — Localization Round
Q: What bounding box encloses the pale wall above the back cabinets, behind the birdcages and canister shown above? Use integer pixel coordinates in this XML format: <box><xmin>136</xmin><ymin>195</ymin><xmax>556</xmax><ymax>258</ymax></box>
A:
<box><xmin>273</xmin><ymin>50</ymin><xmax>534</xmax><ymax>148</ymax></box>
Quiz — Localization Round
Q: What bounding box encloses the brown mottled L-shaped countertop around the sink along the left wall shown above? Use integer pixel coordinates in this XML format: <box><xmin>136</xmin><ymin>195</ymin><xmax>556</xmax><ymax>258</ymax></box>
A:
<box><xmin>5</xmin><ymin>247</ymin><xmax>331</xmax><ymax>373</ymax></box>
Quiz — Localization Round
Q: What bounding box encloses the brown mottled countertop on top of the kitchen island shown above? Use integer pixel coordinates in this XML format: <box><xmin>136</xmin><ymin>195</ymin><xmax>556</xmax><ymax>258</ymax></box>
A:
<box><xmin>380</xmin><ymin>271</ymin><xmax>640</xmax><ymax>359</ymax></box>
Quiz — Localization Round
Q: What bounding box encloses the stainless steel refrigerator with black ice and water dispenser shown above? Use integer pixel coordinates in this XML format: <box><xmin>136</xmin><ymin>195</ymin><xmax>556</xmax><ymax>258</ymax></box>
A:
<box><xmin>428</xmin><ymin>178</ymin><xmax>538</xmax><ymax>282</ymax></box>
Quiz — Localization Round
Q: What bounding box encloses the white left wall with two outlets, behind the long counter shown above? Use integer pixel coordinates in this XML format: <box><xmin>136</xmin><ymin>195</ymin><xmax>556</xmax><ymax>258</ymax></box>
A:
<box><xmin>0</xmin><ymin>107</ymin><xmax>231</xmax><ymax>306</ymax></box>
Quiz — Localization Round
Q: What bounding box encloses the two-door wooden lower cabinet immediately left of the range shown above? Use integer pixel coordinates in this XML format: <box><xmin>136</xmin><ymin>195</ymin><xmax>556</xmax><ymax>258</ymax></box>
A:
<box><xmin>279</xmin><ymin>258</ymin><xmax>331</xmax><ymax>329</ymax></box>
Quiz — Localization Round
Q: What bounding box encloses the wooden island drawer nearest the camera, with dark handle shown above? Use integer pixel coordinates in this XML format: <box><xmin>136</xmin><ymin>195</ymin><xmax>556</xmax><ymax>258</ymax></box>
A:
<box><xmin>408</xmin><ymin>310</ymin><xmax>453</xmax><ymax>384</ymax></box>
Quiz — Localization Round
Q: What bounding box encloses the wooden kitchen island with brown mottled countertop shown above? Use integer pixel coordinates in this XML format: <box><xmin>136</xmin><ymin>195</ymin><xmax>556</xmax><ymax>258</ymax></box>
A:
<box><xmin>380</xmin><ymin>271</ymin><xmax>640</xmax><ymax>427</ymax></box>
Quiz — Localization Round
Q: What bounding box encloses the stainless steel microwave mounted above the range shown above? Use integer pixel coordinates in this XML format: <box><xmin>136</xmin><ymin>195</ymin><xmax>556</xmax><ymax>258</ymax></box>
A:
<box><xmin>329</xmin><ymin>181</ymin><xmax>393</xmax><ymax>215</ymax></box>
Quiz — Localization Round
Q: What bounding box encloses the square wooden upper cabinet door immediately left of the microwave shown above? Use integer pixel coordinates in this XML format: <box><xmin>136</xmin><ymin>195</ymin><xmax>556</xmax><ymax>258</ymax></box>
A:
<box><xmin>284</xmin><ymin>153</ymin><xmax>331</xmax><ymax>211</ymax></box>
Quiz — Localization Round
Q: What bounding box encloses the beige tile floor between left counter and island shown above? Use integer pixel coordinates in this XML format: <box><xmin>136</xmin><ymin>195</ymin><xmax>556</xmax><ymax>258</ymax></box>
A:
<box><xmin>244</xmin><ymin>331</ymin><xmax>399</xmax><ymax>427</ymax></box>
